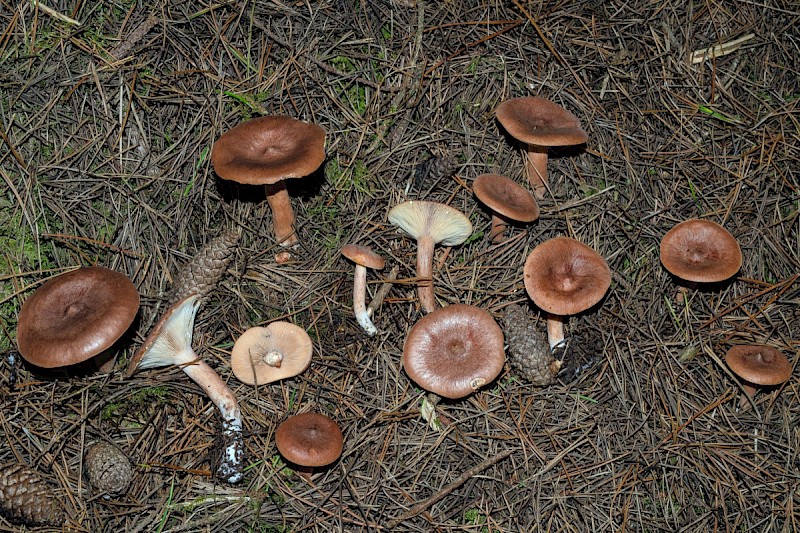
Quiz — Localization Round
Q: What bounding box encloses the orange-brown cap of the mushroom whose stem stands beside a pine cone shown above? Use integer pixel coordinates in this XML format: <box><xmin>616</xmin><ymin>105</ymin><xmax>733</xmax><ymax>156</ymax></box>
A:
<box><xmin>524</xmin><ymin>237</ymin><xmax>611</xmax><ymax>315</ymax></box>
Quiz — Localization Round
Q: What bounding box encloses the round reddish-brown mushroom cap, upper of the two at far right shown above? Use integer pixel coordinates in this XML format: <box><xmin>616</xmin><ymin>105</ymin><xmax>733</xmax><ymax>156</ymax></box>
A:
<box><xmin>661</xmin><ymin>219</ymin><xmax>742</xmax><ymax>283</ymax></box>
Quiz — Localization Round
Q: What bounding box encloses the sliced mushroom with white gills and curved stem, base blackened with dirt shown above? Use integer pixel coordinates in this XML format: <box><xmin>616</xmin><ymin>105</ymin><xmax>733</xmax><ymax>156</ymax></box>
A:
<box><xmin>126</xmin><ymin>294</ymin><xmax>244</xmax><ymax>483</ymax></box>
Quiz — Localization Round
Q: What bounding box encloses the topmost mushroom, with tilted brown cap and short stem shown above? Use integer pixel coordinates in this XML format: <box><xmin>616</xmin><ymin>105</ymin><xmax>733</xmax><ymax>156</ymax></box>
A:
<box><xmin>495</xmin><ymin>96</ymin><xmax>589</xmax><ymax>200</ymax></box>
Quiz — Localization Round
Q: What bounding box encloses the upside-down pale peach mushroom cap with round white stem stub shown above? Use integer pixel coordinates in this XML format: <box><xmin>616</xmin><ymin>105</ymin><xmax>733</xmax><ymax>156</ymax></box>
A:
<box><xmin>231</xmin><ymin>322</ymin><xmax>313</xmax><ymax>385</ymax></box>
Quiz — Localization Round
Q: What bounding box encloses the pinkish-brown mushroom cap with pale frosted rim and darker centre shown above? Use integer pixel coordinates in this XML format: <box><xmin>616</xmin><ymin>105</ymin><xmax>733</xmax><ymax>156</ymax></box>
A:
<box><xmin>403</xmin><ymin>304</ymin><xmax>506</xmax><ymax>399</ymax></box>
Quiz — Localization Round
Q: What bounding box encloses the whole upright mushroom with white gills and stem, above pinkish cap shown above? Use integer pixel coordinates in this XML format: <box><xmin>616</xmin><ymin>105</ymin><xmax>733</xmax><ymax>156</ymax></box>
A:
<box><xmin>388</xmin><ymin>200</ymin><xmax>472</xmax><ymax>313</ymax></box>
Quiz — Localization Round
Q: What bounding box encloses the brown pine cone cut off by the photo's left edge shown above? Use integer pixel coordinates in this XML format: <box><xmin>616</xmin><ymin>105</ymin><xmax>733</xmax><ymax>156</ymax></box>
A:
<box><xmin>0</xmin><ymin>463</ymin><xmax>64</xmax><ymax>526</ymax></box>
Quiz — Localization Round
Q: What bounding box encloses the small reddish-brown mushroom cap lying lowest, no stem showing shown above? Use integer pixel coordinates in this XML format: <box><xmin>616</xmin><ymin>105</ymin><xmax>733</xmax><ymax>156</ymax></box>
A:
<box><xmin>275</xmin><ymin>413</ymin><xmax>344</xmax><ymax>467</ymax></box>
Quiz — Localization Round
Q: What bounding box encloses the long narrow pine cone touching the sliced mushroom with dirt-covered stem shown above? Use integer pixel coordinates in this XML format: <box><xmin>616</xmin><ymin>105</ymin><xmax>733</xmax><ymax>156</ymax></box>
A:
<box><xmin>168</xmin><ymin>230</ymin><xmax>242</xmax><ymax>303</ymax></box>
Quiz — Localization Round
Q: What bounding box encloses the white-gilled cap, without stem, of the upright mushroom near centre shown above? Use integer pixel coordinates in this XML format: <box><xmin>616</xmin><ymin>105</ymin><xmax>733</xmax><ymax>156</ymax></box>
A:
<box><xmin>389</xmin><ymin>200</ymin><xmax>472</xmax><ymax>246</ymax></box>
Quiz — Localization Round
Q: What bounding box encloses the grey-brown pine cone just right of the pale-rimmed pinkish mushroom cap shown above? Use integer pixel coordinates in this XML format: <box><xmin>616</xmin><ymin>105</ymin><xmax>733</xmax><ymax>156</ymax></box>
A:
<box><xmin>503</xmin><ymin>305</ymin><xmax>561</xmax><ymax>386</ymax></box>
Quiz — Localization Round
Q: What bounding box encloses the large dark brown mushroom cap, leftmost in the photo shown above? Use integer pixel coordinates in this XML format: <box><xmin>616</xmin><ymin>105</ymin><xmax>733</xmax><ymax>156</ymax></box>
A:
<box><xmin>17</xmin><ymin>266</ymin><xmax>139</xmax><ymax>368</ymax></box>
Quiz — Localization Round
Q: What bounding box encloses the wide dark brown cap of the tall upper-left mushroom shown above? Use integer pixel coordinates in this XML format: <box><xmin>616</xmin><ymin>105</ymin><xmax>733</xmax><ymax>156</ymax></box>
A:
<box><xmin>211</xmin><ymin>116</ymin><xmax>325</xmax><ymax>185</ymax></box>
